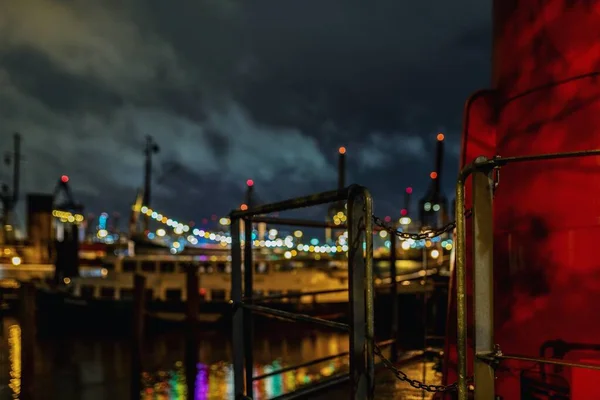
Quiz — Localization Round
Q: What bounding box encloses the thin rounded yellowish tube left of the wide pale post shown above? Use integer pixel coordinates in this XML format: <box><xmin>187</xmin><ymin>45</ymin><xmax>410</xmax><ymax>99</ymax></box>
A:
<box><xmin>456</xmin><ymin>166</ymin><xmax>472</xmax><ymax>400</ymax></box>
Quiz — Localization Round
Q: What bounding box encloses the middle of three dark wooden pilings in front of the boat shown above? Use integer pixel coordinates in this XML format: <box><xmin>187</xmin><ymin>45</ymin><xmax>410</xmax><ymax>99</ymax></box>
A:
<box><xmin>131</xmin><ymin>274</ymin><xmax>146</xmax><ymax>400</ymax></box>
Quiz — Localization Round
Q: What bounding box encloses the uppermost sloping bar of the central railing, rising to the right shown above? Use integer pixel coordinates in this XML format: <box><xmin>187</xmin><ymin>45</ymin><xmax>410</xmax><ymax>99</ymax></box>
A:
<box><xmin>229</xmin><ymin>186</ymin><xmax>352</xmax><ymax>219</ymax></box>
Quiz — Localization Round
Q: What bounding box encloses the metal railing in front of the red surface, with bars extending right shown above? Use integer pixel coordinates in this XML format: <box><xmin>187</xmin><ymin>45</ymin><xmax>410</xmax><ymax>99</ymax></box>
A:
<box><xmin>456</xmin><ymin>150</ymin><xmax>600</xmax><ymax>400</ymax></box>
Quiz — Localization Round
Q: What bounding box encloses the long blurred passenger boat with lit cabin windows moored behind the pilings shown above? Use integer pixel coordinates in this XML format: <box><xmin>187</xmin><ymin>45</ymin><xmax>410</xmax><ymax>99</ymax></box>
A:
<box><xmin>38</xmin><ymin>250</ymin><xmax>356</xmax><ymax>332</ymax></box>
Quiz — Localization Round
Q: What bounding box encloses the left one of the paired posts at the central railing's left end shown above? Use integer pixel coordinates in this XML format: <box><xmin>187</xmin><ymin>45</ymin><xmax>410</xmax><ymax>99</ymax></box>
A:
<box><xmin>231</xmin><ymin>217</ymin><xmax>244</xmax><ymax>400</ymax></box>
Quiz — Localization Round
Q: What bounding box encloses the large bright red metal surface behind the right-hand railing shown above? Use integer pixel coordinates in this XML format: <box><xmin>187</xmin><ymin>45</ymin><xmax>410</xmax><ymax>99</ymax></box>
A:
<box><xmin>446</xmin><ymin>0</ymin><xmax>600</xmax><ymax>400</ymax></box>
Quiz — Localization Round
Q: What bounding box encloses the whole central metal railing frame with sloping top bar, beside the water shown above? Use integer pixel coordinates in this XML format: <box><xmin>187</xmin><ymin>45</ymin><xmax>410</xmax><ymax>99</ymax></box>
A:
<box><xmin>230</xmin><ymin>185</ymin><xmax>376</xmax><ymax>400</ymax></box>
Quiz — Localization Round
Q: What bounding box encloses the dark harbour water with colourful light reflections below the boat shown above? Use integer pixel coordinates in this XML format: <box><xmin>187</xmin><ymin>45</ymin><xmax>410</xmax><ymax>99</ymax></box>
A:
<box><xmin>0</xmin><ymin>319</ymin><xmax>348</xmax><ymax>400</ymax></box>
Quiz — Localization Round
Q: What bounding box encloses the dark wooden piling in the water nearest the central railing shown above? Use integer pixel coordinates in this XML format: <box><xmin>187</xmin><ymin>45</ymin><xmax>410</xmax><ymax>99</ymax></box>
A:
<box><xmin>184</xmin><ymin>264</ymin><xmax>200</xmax><ymax>399</ymax></box>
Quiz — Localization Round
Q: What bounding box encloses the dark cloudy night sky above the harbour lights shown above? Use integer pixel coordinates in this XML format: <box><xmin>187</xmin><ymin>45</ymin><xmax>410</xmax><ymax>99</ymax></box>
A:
<box><xmin>0</xmin><ymin>0</ymin><xmax>491</xmax><ymax>227</ymax></box>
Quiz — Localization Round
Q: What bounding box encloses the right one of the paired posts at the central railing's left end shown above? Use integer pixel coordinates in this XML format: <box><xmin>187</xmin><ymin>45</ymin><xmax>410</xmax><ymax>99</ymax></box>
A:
<box><xmin>244</xmin><ymin>217</ymin><xmax>254</xmax><ymax>399</ymax></box>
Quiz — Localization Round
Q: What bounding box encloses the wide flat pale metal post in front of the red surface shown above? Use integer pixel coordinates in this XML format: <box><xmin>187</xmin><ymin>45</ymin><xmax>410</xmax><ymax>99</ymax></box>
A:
<box><xmin>473</xmin><ymin>157</ymin><xmax>495</xmax><ymax>400</ymax></box>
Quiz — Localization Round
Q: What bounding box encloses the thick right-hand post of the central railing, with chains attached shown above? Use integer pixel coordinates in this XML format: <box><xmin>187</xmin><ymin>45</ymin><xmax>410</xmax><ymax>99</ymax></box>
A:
<box><xmin>348</xmin><ymin>186</ymin><xmax>375</xmax><ymax>400</ymax></box>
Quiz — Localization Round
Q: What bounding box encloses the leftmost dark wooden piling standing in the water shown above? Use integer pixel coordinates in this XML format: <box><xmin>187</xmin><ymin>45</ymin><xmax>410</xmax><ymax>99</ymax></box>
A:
<box><xmin>19</xmin><ymin>282</ymin><xmax>36</xmax><ymax>400</ymax></box>
